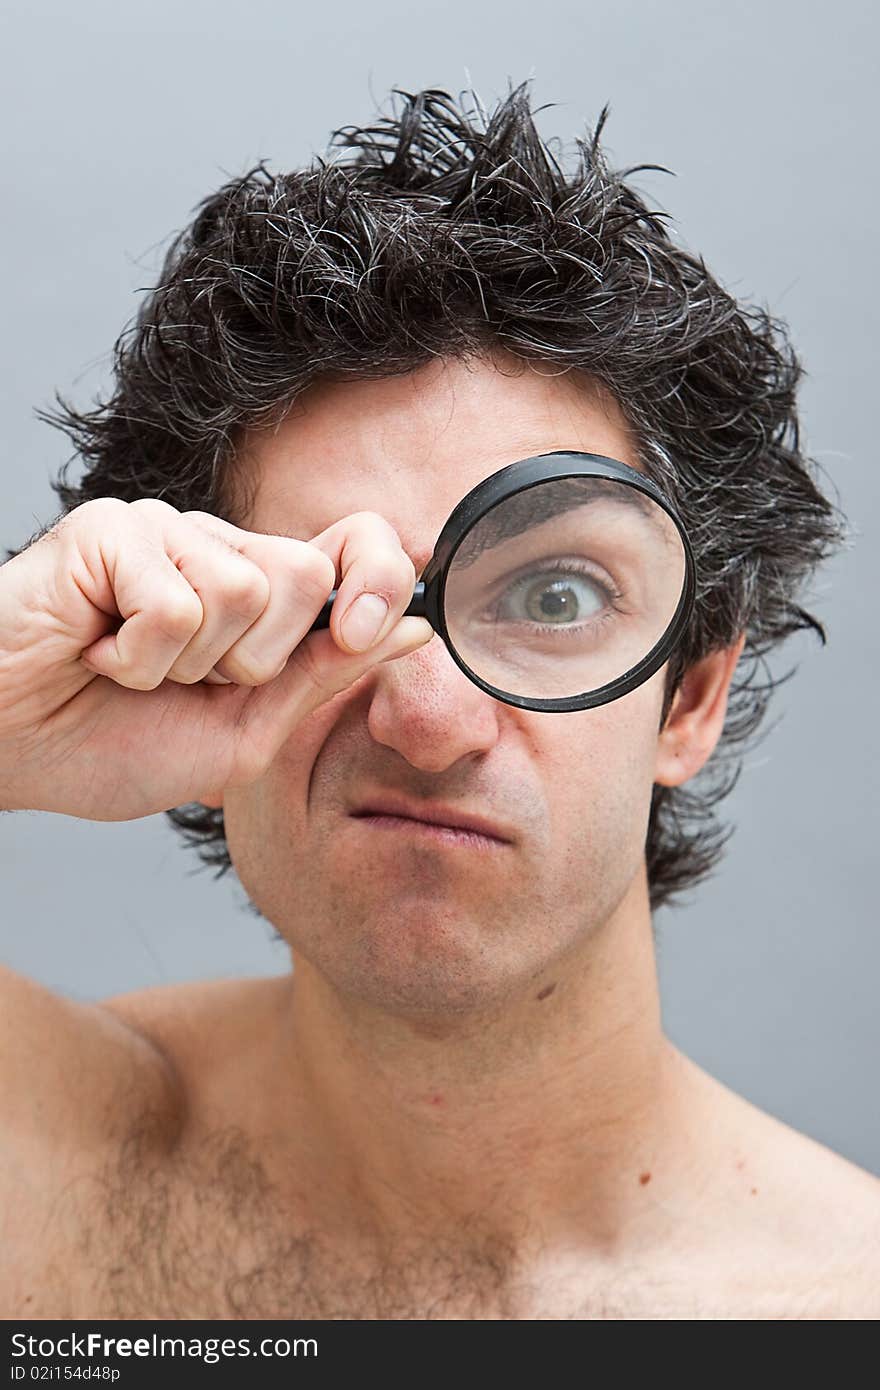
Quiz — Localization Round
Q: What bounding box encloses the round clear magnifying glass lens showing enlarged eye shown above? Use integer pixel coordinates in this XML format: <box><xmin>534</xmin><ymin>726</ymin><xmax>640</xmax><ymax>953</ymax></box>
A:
<box><xmin>443</xmin><ymin>477</ymin><xmax>687</xmax><ymax>699</ymax></box>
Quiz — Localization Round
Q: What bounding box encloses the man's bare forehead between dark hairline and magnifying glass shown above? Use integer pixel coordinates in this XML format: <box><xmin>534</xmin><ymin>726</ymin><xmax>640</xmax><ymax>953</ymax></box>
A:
<box><xmin>239</xmin><ymin>357</ymin><xmax>638</xmax><ymax>542</ymax></box>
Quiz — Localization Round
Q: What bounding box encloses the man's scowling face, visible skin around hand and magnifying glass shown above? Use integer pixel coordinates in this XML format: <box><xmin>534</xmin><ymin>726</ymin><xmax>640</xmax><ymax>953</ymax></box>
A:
<box><xmin>224</xmin><ymin>354</ymin><xmax>665</xmax><ymax>1017</ymax></box>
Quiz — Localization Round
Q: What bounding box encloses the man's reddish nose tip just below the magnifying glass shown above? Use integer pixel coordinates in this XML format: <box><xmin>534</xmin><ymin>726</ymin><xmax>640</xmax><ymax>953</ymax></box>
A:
<box><xmin>367</xmin><ymin>634</ymin><xmax>505</xmax><ymax>773</ymax></box>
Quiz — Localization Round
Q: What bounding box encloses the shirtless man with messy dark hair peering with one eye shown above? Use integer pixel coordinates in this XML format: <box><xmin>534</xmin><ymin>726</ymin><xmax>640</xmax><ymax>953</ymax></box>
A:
<box><xmin>0</xmin><ymin>81</ymin><xmax>880</xmax><ymax>1319</ymax></box>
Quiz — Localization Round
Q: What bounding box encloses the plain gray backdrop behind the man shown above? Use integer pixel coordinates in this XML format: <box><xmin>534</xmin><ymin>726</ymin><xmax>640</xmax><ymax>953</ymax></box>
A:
<box><xmin>0</xmin><ymin>0</ymin><xmax>880</xmax><ymax>1172</ymax></box>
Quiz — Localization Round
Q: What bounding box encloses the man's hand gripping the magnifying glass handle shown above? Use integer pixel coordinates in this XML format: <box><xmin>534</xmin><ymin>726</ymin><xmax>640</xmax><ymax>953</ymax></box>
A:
<box><xmin>0</xmin><ymin>498</ymin><xmax>434</xmax><ymax>820</ymax></box>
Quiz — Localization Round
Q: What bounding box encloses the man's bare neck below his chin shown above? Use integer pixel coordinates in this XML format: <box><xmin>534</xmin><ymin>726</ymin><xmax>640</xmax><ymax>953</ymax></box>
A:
<box><xmin>246</xmin><ymin>909</ymin><xmax>692</xmax><ymax>1255</ymax></box>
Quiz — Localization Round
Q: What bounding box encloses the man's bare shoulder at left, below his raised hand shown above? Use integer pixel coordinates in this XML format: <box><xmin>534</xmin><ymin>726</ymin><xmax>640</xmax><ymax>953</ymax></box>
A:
<box><xmin>0</xmin><ymin>967</ymin><xmax>193</xmax><ymax>1311</ymax></box>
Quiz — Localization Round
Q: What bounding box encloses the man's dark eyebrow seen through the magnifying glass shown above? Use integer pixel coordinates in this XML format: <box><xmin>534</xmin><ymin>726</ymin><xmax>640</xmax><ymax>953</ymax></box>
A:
<box><xmin>455</xmin><ymin>478</ymin><xmax>669</xmax><ymax>566</ymax></box>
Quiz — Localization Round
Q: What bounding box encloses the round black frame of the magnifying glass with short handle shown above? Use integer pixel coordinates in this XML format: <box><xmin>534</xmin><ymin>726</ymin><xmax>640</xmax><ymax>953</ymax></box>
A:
<box><xmin>310</xmin><ymin>449</ymin><xmax>696</xmax><ymax>714</ymax></box>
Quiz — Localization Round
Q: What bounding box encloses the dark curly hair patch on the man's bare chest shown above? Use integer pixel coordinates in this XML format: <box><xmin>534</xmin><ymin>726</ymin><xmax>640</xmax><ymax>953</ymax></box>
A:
<box><xmin>35</xmin><ymin>1123</ymin><xmax>578</xmax><ymax>1319</ymax></box>
